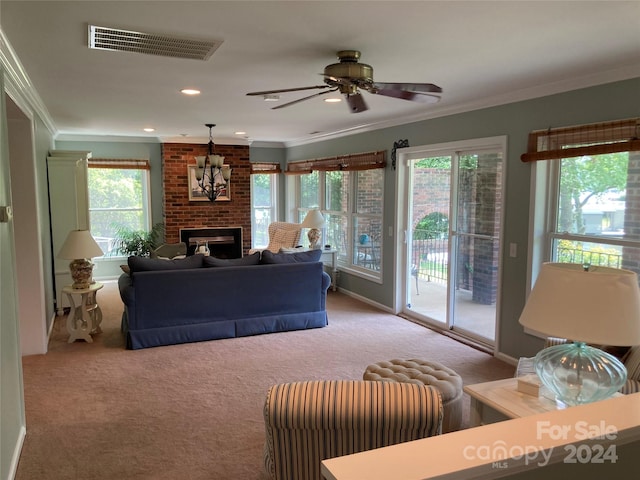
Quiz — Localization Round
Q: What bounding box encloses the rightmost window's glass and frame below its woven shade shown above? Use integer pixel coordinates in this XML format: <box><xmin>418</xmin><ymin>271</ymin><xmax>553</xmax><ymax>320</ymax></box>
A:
<box><xmin>549</xmin><ymin>152</ymin><xmax>640</xmax><ymax>273</ymax></box>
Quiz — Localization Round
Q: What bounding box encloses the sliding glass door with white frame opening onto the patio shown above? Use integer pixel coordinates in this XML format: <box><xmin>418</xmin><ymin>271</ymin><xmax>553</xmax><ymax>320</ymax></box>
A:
<box><xmin>397</xmin><ymin>137</ymin><xmax>505</xmax><ymax>348</ymax></box>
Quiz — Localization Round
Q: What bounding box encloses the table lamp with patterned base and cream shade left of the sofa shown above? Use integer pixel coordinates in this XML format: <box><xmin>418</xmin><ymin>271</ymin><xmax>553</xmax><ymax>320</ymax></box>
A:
<box><xmin>58</xmin><ymin>230</ymin><xmax>104</xmax><ymax>289</ymax></box>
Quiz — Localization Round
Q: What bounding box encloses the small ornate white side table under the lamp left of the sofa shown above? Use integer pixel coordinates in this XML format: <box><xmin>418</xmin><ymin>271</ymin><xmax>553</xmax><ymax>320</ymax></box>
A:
<box><xmin>62</xmin><ymin>282</ymin><xmax>103</xmax><ymax>343</ymax></box>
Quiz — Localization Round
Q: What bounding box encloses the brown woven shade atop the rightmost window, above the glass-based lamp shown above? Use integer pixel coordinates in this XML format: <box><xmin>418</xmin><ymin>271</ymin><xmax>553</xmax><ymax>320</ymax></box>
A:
<box><xmin>520</xmin><ymin>118</ymin><xmax>640</xmax><ymax>162</ymax></box>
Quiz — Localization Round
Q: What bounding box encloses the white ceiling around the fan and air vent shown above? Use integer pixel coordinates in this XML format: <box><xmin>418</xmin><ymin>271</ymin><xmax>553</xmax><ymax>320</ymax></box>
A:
<box><xmin>0</xmin><ymin>0</ymin><xmax>640</xmax><ymax>145</ymax></box>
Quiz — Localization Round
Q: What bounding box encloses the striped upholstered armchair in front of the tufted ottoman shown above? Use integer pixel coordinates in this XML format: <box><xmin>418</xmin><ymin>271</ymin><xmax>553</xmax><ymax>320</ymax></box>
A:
<box><xmin>264</xmin><ymin>380</ymin><xmax>442</xmax><ymax>480</ymax></box>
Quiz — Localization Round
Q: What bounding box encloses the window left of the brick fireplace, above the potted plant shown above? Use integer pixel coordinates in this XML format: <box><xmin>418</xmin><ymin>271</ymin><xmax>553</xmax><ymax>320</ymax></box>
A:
<box><xmin>88</xmin><ymin>158</ymin><xmax>151</xmax><ymax>257</ymax></box>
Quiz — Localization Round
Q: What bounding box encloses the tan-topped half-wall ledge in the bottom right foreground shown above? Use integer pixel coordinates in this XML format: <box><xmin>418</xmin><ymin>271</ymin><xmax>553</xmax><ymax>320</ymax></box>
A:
<box><xmin>321</xmin><ymin>393</ymin><xmax>640</xmax><ymax>480</ymax></box>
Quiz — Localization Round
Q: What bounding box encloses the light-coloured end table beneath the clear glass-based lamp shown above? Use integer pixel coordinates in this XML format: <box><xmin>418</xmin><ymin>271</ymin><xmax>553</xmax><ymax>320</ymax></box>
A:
<box><xmin>464</xmin><ymin>378</ymin><xmax>566</xmax><ymax>427</ymax></box>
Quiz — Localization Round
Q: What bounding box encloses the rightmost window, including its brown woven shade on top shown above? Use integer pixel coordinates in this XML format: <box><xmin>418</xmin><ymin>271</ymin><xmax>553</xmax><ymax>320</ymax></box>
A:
<box><xmin>523</xmin><ymin>120</ymin><xmax>640</xmax><ymax>280</ymax></box>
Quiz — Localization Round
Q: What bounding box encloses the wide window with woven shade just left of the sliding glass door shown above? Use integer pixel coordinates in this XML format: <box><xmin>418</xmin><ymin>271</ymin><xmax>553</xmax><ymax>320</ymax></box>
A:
<box><xmin>288</xmin><ymin>152</ymin><xmax>385</xmax><ymax>279</ymax></box>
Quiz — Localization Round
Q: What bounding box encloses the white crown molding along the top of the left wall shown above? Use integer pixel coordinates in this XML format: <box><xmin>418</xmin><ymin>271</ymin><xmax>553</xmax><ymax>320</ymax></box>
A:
<box><xmin>0</xmin><ymin>28</ymin><xmax>58</xmax><ymax>138</ymax></box>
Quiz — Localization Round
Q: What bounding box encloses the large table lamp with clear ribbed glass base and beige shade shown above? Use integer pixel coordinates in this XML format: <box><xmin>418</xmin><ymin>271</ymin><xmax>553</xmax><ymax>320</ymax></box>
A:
<box><xmin>520</xmin><ymin>263</ymin><xmax>640</xmax><ymax>405</ymax></box>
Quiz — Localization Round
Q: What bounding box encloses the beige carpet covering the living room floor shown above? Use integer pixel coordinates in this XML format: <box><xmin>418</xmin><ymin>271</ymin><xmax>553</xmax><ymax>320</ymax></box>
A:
<box><xmin>16</xmin><ymin>283</ymin><xmax>514</xmax><ymax>480</ymax></box>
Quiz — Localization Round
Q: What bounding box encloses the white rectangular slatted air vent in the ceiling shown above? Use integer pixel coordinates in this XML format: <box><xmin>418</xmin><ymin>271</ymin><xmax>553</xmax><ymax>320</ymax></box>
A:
<box><xmin>89</xmin><ymin>25</ymin><xmax>222</xmax><ymax>60</ymax></box>
